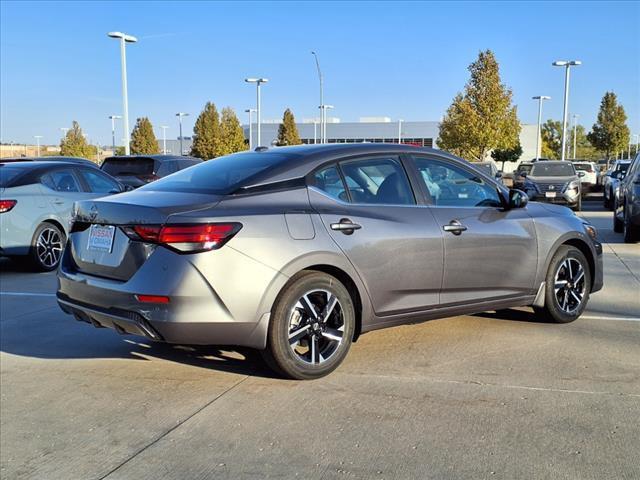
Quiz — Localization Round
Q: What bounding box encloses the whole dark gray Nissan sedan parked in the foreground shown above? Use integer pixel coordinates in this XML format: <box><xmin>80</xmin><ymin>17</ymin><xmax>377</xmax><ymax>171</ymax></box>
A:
<box><xmin>58</xmin><ymin>144</ymin><xmax>603</xmax><ymax>379</ymax></box>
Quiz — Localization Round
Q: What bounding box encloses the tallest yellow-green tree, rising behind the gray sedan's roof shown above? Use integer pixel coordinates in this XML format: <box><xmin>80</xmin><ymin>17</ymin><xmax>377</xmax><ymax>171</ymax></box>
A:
<box><xmin>437</xmin><ymin>50</ymin><xmax>520</xmax><ymax>161</ymax></box>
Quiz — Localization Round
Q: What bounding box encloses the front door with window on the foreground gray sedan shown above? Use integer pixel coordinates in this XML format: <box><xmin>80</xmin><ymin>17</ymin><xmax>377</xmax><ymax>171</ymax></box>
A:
<box><xmin>412</xmin><ymin>156</ymin><xmax>537</xmax><ymax>306</ymax></box>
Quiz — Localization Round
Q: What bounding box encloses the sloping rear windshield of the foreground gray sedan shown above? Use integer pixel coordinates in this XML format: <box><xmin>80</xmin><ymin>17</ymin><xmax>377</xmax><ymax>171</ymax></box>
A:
<box><xmin>142</xmin><ymin>152</ymin><xmax>293</xmax><ymax>194</ymax></box>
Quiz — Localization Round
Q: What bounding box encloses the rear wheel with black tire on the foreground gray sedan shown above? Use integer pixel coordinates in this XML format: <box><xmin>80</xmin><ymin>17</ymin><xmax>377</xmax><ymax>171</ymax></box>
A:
<box><xmin>262</xmin><ymin>271</ymin><xmax>356</xmax><ymax>380</ymax></box>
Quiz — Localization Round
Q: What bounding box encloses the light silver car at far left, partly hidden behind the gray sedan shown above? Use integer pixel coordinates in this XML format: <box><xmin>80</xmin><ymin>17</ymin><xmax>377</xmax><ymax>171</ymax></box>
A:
<box><xmin>0</xmin><ymin>160</ymin><xmax>123</xmax><ymax>271</ymax></box>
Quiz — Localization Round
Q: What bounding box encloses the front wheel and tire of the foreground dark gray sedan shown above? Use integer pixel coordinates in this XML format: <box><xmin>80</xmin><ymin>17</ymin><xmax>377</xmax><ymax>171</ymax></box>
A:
<box><xmin>534</xmin><ymin>245</ymin><xmax>591</xmax><ymax>323</ymax></box>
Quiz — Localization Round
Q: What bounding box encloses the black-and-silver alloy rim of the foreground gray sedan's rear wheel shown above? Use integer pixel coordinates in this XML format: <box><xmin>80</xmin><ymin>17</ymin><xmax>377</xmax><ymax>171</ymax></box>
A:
<box><xmin>288</xmin><ymin>290</ymin><xmax>345</xmax><ymax>365</ymax></box>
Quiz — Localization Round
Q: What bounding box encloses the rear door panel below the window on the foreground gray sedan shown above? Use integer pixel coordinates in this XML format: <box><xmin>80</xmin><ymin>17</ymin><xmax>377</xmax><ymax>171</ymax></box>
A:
<box><xmin>309</xmin><ymin>156</ymin><xmax>443</xmax><ymax>316</ymax></box>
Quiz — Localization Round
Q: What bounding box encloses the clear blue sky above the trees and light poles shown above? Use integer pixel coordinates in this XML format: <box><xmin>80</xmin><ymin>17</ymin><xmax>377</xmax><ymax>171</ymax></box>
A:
<box><xmin>0</xmin><ymin>1</ymin><xmax>640</xmax><ymax>144</ymax></box>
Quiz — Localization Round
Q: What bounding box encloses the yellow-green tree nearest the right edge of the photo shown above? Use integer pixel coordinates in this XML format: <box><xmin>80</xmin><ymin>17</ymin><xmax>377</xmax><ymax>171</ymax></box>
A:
<box><xmin>587</xmin><ymin>92</ymin><xmax>630</xmax><ymax>163</ymax></box>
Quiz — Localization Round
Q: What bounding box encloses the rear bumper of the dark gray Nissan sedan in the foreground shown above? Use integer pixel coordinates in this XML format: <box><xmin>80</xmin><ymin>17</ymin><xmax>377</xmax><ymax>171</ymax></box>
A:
<box><xmin>58</xmin><ymin>242</ymin><xmax>282</xmax><ymax>349</ymax></box>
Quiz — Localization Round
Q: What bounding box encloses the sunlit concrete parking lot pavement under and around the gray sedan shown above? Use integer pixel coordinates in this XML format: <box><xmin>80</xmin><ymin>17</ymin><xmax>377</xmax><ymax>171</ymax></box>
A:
<box><xmin>0</xmin><ymin>197</ymin><xmax>640</xmax><ymax>480</ymax></box>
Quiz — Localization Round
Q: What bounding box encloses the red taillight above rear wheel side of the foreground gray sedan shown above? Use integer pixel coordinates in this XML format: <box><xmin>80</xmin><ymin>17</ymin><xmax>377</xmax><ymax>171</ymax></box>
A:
<box><xmin>123</xmin><ymin>222</ymin><xmax>242</xmax><ymax>253</ymax></box>
